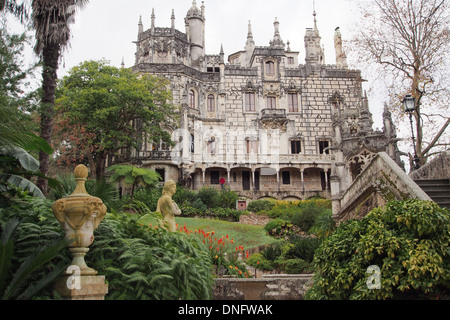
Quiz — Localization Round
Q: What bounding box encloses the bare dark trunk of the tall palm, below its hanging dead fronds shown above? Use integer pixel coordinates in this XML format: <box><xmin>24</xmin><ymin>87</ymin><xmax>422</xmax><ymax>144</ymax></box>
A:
<box><xmin>37</xmin><ymin>41</ymin><xmax>60</xmax><ymax>195</ymax></box>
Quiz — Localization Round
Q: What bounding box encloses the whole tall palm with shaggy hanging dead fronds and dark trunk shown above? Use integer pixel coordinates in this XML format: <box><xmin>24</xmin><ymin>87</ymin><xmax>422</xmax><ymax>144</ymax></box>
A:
<box><xmin>31</xmin><ymin>0</ymin><xmax>89</xmax><ymax>194</ymax></box>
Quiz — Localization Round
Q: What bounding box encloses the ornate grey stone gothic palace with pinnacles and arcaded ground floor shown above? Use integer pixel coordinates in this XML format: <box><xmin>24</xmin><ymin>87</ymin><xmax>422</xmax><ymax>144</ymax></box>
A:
<box><xmin>116</xmin><ymin>0</ymin><xmax>399</xmax><ymax>200</ymax></box>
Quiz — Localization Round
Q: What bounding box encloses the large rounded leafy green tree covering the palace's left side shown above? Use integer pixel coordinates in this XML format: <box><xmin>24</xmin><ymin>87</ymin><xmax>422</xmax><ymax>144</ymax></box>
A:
<box><xmin>57</xmin><ymin>61</ymin><xmax>177</xmax><ymax>180</ymax></box>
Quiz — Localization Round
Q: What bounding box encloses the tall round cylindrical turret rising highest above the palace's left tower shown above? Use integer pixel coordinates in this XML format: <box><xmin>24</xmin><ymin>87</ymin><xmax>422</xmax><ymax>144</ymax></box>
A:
<box><xmin>185</xmin><ymin>0</ymin><xmax>205</xmax><ymax>67</ymax></box>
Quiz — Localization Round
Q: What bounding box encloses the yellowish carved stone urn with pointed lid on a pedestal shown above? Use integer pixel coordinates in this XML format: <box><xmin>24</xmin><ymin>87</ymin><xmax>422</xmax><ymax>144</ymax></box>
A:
<box><xmin>52</xmin><ymin>164</ymin><xmax>106</xmax><ymax>275</ymax></box>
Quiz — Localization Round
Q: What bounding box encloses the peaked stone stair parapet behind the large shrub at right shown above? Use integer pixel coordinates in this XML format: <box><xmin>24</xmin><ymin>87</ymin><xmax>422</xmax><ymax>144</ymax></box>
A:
<box><xmin>332</xmin><ymin>152</ymin><xmax>431</xmax><ymax>222</ymax></box>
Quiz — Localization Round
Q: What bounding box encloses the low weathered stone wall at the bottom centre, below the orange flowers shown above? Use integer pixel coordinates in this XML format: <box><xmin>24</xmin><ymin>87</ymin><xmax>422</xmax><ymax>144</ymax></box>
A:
<box><xmin>213</xmin><ymin>274</ymin><xmax>313</xmax><ymax>300</ymax></box>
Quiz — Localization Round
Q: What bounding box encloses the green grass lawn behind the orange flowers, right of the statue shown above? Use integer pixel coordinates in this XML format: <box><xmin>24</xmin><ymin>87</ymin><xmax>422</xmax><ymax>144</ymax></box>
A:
<box><xmin>175</xmin><ymin>218</ymin><xmax>276</xmax><ymax>250</ymax></box>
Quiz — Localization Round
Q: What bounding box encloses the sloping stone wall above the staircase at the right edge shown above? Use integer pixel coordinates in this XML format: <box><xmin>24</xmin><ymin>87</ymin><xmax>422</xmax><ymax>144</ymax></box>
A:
<box><xmin>409</xmin><ymin>151</ymin><xmax>450</xmax><ymax>180</ymax></box>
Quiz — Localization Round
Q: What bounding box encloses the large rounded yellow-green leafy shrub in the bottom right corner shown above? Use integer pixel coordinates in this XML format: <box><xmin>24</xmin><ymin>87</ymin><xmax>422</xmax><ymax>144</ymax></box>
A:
<box><xmin>308</xmin><ymin>200</ymin><xmax>450</xmax><ymax>299</ymax></box>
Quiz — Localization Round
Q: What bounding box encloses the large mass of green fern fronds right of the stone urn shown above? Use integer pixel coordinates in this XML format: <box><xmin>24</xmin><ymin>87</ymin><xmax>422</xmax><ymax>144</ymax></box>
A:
<box><xmin>86</xmin><ymin>213</ymin><xmax>213</xmax><ymax>300</ymax></box>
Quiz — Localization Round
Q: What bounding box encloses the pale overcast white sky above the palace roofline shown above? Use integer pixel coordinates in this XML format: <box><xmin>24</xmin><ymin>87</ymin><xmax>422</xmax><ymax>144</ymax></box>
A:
<box><xmin>6</xmin><ymin>0</ymin><xmax>383</xmax><ymax>128</ymax></box>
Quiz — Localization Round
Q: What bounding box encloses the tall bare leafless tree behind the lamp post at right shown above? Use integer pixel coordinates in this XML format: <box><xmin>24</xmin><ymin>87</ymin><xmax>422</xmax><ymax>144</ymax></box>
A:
<box><xmin>352</xmin><ymin>0</ymin><xmax>450</xmax><ymax>169</ymax></box>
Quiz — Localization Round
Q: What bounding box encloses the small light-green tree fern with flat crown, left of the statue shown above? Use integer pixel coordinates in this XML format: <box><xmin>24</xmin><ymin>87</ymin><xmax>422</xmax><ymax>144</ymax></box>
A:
<box><xmin>107</xmin><ymin>165</ymin><xmax>161</xmax><ymax>202</ymax></box>
